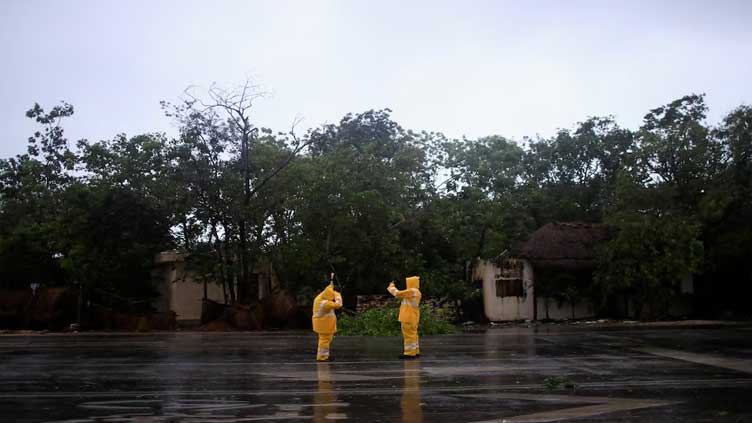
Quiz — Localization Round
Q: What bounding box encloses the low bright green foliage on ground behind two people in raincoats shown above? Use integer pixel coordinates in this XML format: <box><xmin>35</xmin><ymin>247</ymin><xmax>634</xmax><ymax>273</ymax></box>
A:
<box><xmin>337</xmin><ymin>305</ymin><xmax>454</xmax><ymax>336</ymax></box>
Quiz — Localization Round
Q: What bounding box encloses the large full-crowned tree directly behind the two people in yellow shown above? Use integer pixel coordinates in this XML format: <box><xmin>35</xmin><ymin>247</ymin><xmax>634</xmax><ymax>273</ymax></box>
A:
<box><xmin>280</xmin><ymin>110</ymin><xmax>431</xmax><ymax>292</ymax></box>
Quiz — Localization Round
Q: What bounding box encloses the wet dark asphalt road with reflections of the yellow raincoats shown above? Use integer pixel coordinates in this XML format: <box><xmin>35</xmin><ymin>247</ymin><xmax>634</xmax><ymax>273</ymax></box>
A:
<box><xmin>0</xmin><ymin>326</ymin><xmax>752</xmax><ymax>423</ymax></box>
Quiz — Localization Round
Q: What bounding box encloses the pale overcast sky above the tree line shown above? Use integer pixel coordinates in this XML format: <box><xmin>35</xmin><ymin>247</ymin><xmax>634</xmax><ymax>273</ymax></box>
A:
<box><xmin>0</xmin><ymin>0</ymin><xmax>752</xmax><ymax>157</ymax></box>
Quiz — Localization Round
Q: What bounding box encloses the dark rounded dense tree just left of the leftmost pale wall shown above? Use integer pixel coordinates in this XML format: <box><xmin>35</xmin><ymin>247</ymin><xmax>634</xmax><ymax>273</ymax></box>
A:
<box><xmin>55</xmin><ymin>183</ymin><xmax>172</xmax><ymax>311</ymax></box>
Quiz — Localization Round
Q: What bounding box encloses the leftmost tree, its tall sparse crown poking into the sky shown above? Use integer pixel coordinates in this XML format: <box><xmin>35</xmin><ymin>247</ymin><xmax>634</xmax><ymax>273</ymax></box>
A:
<box><xmin>0</xmin><ymin>103</ymin><xmax>76</xmax><ymax>287</ymax></box>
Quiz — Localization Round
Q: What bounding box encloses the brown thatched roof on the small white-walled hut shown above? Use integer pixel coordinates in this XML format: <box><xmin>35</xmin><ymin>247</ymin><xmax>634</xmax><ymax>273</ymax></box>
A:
<box><xmin>519</xmin><ymin>222</ymin><xmax>610</xmax><ymax>269</ymax></box>
